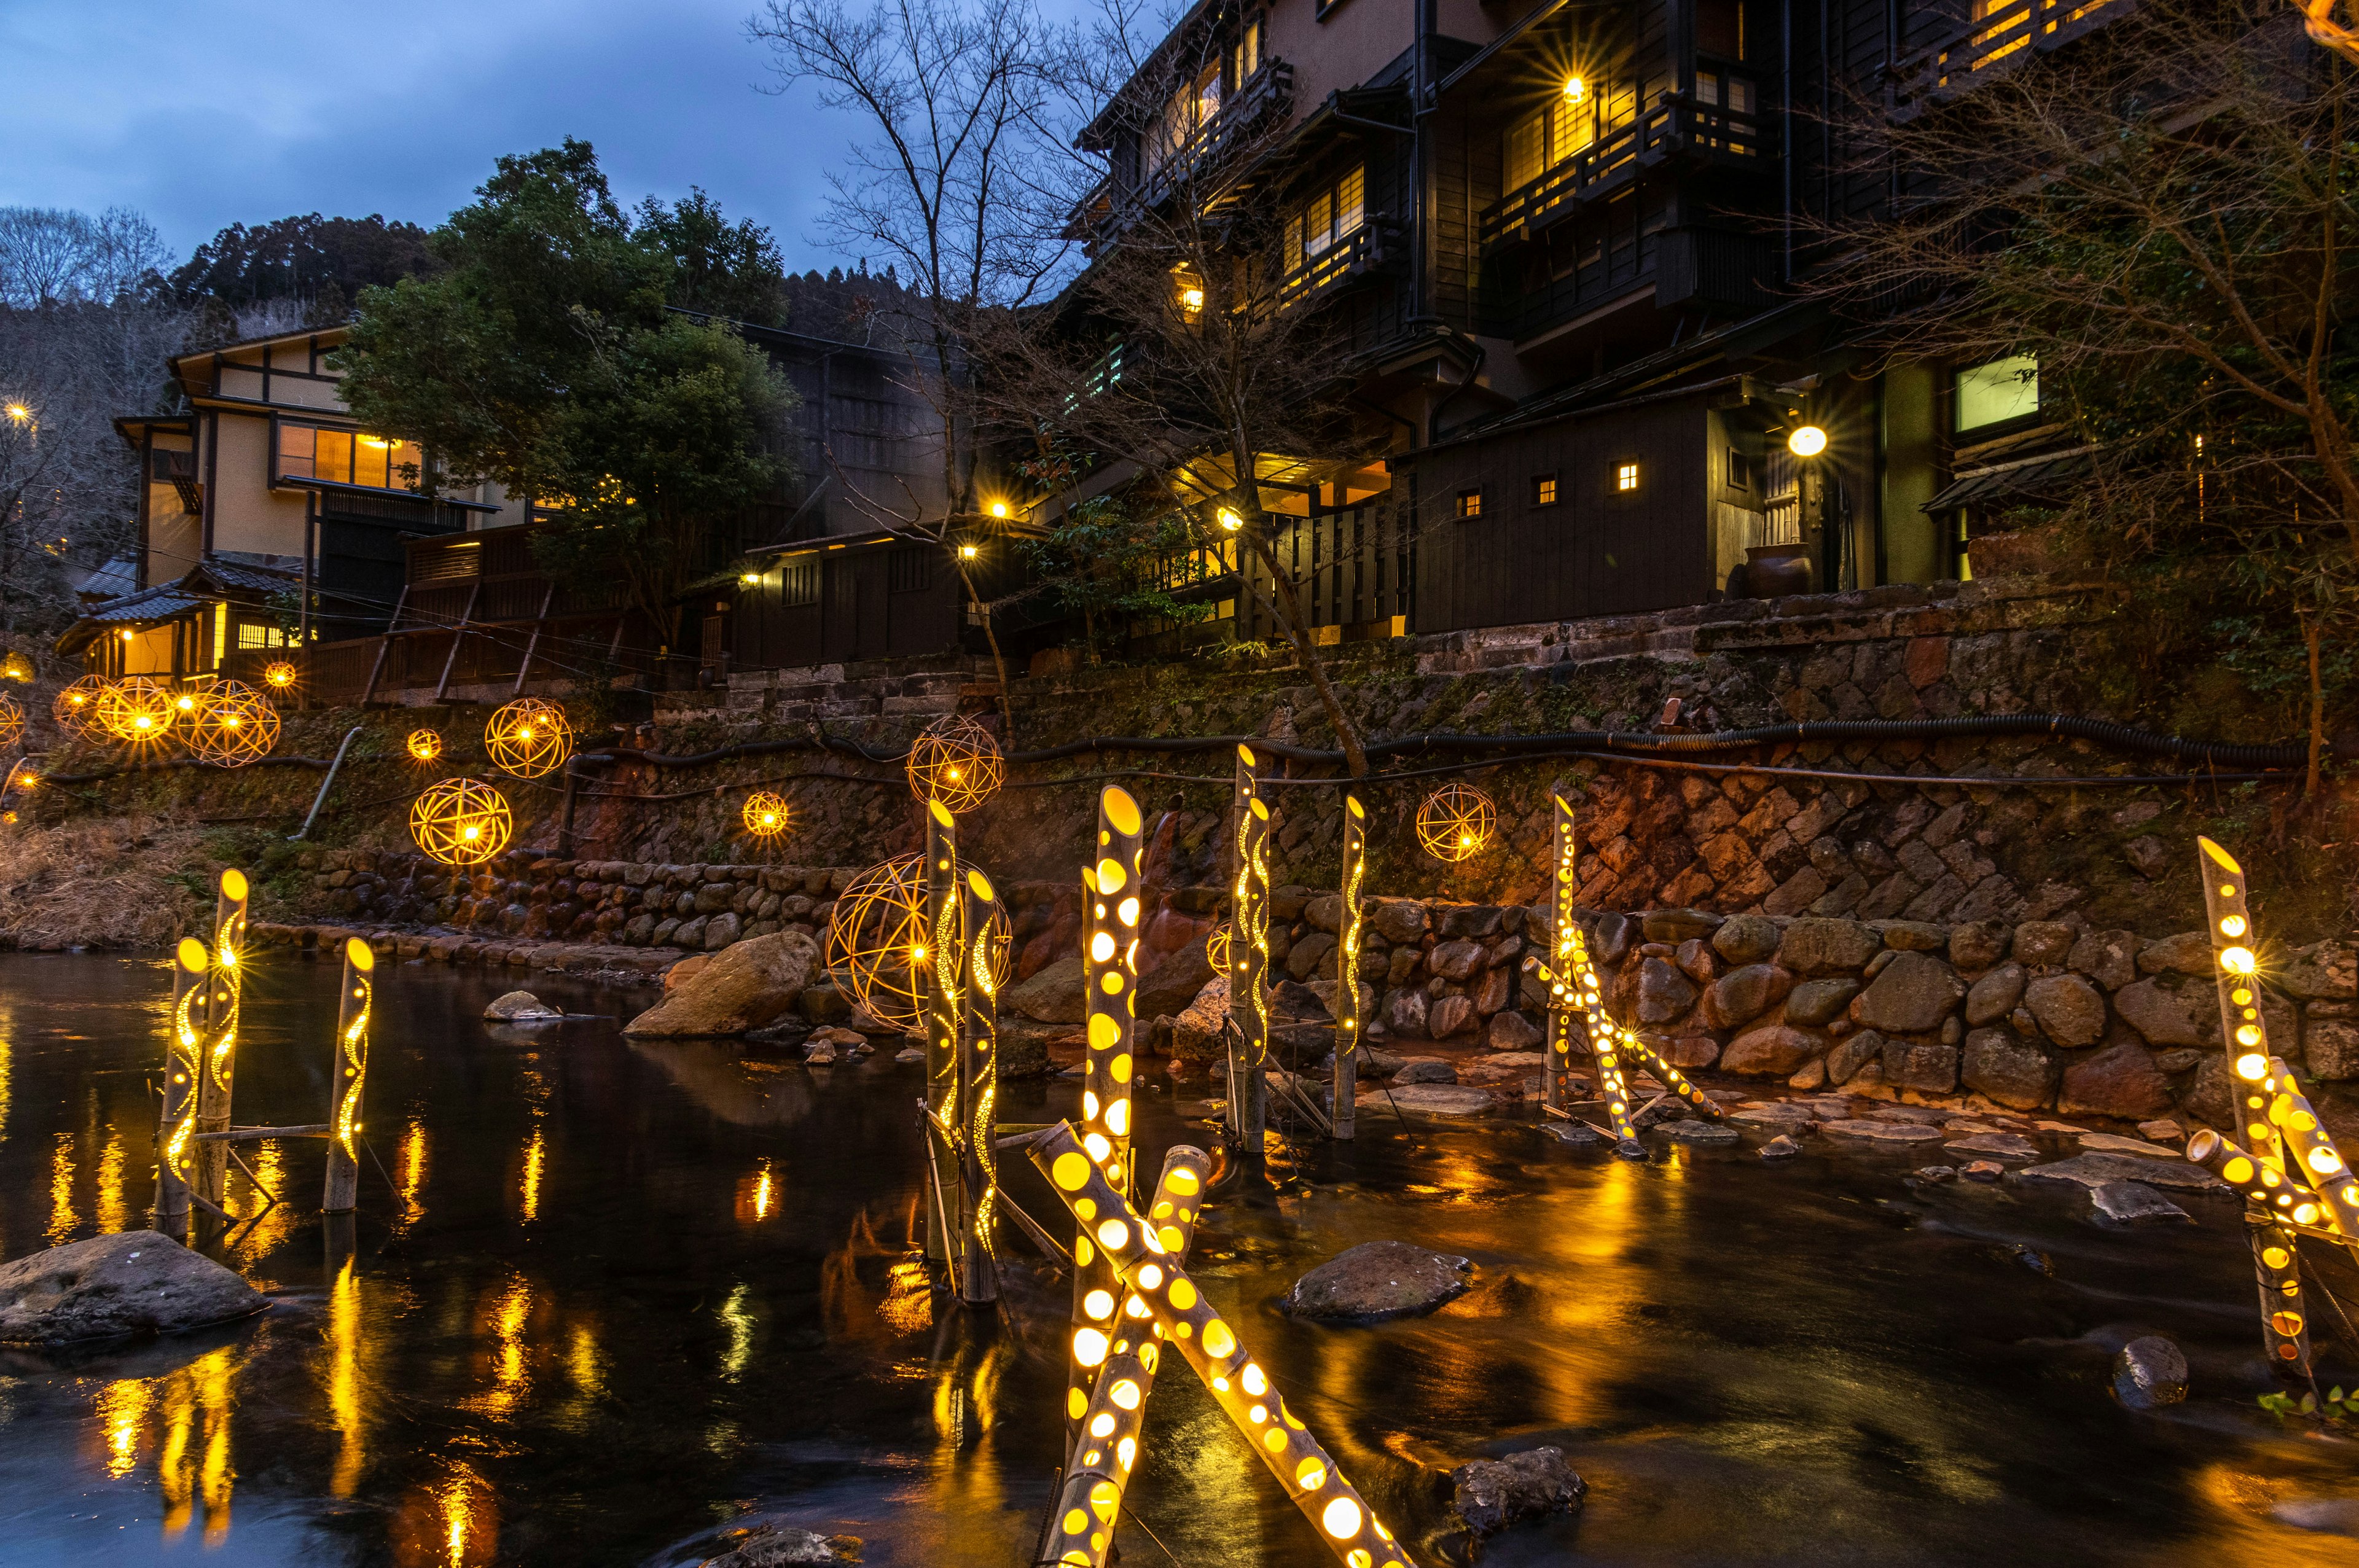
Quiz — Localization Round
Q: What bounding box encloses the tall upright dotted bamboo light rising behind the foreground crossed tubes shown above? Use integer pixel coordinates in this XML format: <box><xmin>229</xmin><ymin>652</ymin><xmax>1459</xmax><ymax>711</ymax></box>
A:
<box><xmin>1064</xmin><ymin>785</ymin><xmax>1146</xmax><ymax>1443</ymax></box>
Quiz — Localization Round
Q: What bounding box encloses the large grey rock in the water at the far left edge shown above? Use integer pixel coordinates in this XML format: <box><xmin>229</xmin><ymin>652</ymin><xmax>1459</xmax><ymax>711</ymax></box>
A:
<box><xmin>0</xmin><ymin>1231</ymin><xmax>269</xmax><ymax>1344</ymax></box>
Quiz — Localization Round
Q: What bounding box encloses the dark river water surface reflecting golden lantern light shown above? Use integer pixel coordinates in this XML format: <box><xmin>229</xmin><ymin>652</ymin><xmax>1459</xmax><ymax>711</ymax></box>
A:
<box><xmin>0</xmin><ymin>955</ymin><xmax>2359</xmax><ymax>1568</ymax></box>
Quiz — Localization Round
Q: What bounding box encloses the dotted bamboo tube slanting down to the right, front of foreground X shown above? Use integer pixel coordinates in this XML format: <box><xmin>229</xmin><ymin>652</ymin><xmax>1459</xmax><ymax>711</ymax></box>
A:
<box><xmin>1031</xmin><ymin>1125</ymin><xmax>1410</xmax><ymax>1568</ymax></box>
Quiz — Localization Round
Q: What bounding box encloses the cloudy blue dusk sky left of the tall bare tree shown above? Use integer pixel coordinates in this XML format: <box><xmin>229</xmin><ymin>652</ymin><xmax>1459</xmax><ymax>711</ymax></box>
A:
<box><xmin>0</xmin><ymin>0</ymin><xmax>929</xmax><ymax>271</ymax></box>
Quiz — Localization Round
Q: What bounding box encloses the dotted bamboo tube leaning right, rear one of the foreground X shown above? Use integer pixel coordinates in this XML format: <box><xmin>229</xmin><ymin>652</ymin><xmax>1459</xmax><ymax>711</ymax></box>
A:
<box><xmin>1040</xmin><ymin>1144</ymin><xmax>1213</xmax><ymax>1568</ymax></box>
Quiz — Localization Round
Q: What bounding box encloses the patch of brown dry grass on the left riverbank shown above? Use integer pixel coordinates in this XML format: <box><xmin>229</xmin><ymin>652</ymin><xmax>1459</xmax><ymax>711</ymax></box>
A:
<box><xmin>0</xmin><ymin>816</ymin><xmax>210</xmax><ymax>948</ymax></box>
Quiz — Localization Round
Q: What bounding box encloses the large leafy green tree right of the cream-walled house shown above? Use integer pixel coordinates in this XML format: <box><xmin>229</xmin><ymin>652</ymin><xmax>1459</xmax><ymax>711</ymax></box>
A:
<box><xmin>342</xmin><ymin>139</ymin><xmax>795</xmax><ymax>644</ymax></box>
